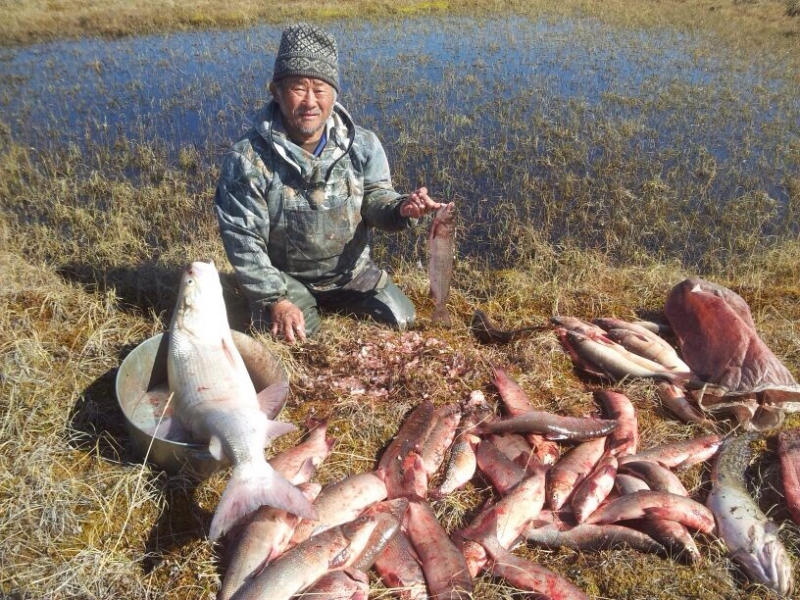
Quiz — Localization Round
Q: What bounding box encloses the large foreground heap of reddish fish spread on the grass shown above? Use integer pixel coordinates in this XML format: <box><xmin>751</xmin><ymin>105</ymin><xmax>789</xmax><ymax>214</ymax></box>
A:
<box><xmin>220</xmin><ymin>368</ymin><xmax>797</xmax><ymax>599</ymax></box>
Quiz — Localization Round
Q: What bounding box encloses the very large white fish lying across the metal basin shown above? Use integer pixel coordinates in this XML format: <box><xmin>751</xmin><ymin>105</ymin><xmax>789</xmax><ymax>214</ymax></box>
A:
<box><xmin>167</xmin><ymin>262</ymin><xmax>317</xmax><ymax>541</ymax></box>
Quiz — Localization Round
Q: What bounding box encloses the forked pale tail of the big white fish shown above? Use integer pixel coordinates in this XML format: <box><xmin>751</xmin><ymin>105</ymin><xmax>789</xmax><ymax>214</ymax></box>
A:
<box><xmin>208</xmin><ymin>462</ymin><xmax>319</xmax><ymax>542</ymax></box>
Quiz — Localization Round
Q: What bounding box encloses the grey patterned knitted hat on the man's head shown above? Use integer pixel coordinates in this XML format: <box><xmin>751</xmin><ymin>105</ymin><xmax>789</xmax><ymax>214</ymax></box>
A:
<box><xmin>272</xmin><ymin>23</ymin><xmax>339</xmax><ymax>92</ymax></box>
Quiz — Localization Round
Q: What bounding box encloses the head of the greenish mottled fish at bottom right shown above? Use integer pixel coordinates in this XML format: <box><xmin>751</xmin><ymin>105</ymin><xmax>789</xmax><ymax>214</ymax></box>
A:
<box><xmin>731</xmin><ymin>526</ymin><xmax>794</xmax><ymax>597</ymax></box>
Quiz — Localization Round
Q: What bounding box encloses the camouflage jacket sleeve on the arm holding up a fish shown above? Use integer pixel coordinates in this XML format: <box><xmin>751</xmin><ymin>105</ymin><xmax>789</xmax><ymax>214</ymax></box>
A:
<box><xmin>356</xmin><ymin>129</ymin><xmax>417</xmax><ymax>231</ymax></box>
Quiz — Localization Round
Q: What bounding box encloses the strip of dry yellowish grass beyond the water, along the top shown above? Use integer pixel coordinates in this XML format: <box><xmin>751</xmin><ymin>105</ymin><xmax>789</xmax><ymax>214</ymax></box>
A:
<box><xmin>0</xmin><ymin>0</ymin><xmax>800</xmax><ymax>44</ymax></box>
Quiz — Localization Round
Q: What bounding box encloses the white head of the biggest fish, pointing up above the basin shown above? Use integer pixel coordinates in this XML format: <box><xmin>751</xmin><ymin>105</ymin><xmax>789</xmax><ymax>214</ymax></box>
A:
<box><xmin>171</xmin><ymin>261</ymin><xmax>230</xmax><ymax>336</ymax></box>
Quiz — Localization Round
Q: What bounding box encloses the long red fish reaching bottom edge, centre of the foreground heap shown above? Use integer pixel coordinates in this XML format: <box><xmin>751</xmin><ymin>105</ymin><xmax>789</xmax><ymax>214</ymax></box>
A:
<box><xmin>403</xmin><ymin>500</ymin><xmax>472</xmax><ymax>600</ymax></box>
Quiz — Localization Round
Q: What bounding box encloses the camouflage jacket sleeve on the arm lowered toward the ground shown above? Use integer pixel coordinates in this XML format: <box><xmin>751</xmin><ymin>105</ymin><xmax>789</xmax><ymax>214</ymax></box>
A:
<box><xmin>214</xmin><ymin>151</ymin><xmax>286</xmax><ymax>306</ymax></box>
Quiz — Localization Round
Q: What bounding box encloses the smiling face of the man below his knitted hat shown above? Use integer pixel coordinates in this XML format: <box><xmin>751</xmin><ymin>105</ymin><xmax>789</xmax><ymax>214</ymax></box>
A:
<box><xmin>270</xmin><ymin>77</ymin><xmax>336</xmax><ymax>142</ymax></box>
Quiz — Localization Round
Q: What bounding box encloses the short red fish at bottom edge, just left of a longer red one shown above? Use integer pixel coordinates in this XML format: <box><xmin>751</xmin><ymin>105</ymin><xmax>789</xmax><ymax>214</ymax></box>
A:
<box><xmin>374</xmin><ymin>529</ymin><xmax>428</xmax><ymax>600</ymax></box>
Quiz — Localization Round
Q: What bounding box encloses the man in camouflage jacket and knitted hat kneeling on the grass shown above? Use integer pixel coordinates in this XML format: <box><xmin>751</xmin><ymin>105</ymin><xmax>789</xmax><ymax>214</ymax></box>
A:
<box><xmin>216</xmin><ymin>23</ymin><xmax>441</xmax><ymax>343</ymax></box>
